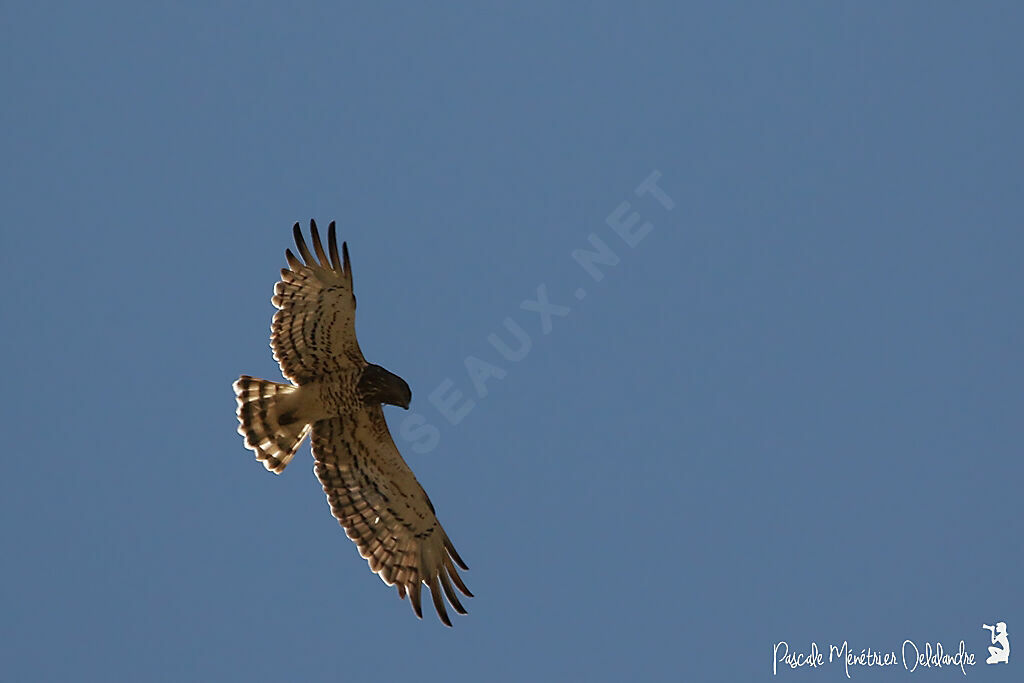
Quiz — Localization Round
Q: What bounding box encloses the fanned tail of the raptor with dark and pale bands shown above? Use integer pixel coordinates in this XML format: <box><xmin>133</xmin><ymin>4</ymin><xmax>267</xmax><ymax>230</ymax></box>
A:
<box><xmin>234</xmin><ymin>375</ymin><xmax>312</xmax><ymax>474</ymax></box>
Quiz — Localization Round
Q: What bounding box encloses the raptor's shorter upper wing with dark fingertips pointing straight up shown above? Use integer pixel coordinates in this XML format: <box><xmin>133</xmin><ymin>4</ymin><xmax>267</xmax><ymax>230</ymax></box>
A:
<box><xmin>270</xmin><ymin>220</ymin><xmax>366</xmax><ymax>384</ymax></box>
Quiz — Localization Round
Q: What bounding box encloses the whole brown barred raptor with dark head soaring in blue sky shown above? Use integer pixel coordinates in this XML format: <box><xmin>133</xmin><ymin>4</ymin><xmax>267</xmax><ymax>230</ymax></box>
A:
<box><xmin>234</xmin><ymin>220</ymin><xmax>473</xmax><ymax>626</ymax></box>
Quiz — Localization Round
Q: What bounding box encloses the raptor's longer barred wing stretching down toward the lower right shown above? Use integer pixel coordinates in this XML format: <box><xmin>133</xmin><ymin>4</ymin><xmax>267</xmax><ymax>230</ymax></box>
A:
<box><xmin>312</xmin><ymin>405</ymin><xmax>473</xmax><ymax>626</ymax></box>
